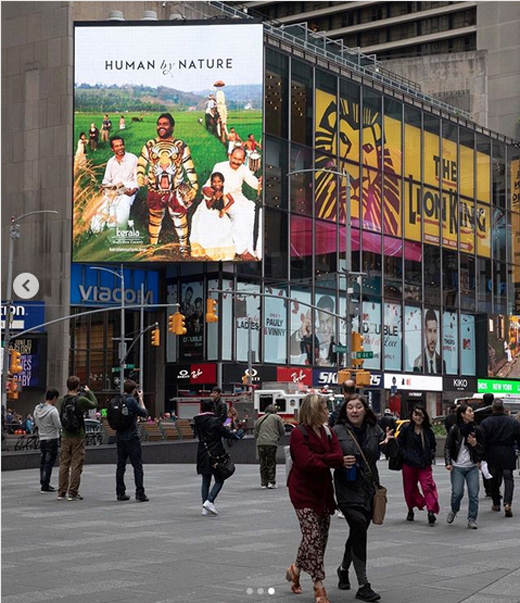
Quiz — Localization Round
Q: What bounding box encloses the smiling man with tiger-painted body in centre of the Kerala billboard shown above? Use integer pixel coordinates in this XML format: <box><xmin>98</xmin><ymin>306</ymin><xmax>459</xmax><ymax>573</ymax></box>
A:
<box><xmin>137</xmin><ymin>113</ymin><xmax>199</xmax><ymax>258</ymax></box>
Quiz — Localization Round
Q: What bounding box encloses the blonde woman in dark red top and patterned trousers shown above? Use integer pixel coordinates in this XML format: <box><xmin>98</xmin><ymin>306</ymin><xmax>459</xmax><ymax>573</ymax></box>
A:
<box><xmin>286</xmin><ymin>394</ymin><xmax>344</xmax><ymax>603</ymax></box>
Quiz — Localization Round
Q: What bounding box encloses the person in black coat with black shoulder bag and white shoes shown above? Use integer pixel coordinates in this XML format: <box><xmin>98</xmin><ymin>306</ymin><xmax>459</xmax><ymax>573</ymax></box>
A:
<box><xmin>193</xmin><ymin>400</ymin><xmax>239</xmax><ymax>515</ymax></box>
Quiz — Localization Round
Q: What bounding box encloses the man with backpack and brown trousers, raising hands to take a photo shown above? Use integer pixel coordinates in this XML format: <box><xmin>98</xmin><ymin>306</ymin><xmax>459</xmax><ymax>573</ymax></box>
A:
<box><xmin>58</xmin><ymin>376</ymin><xmax>98</xmax><ymax>501</ymax></box>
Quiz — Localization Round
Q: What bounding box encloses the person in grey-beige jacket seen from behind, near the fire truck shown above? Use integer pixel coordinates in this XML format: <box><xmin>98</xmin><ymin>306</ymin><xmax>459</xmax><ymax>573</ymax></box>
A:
<box><xmin>254</xmin><ymin>404</ymin><xmax>285</xmax><ymax>489</ymax></box>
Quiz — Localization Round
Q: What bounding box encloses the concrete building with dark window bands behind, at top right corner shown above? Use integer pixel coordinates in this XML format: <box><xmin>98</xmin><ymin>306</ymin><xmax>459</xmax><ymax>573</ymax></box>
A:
<box><xmin>239</xmin><ymin>1</ymin><xmax>520</xmax><ymax>138</ymax></box>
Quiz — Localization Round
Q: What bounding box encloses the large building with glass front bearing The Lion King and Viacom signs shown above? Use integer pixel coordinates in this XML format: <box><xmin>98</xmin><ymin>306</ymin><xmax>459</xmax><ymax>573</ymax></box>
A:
<box><xmin>2</xmin><ymin>2</ymin><xmax>520</xmax><ymax>424</ymax></box>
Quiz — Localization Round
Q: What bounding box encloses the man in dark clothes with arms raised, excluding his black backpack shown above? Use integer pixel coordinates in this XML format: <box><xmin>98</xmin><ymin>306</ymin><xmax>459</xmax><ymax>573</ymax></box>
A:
<box><xmin>116</xmin><ymin>379</ymin><xmax>149</xmax><ymax>502</ymax></box>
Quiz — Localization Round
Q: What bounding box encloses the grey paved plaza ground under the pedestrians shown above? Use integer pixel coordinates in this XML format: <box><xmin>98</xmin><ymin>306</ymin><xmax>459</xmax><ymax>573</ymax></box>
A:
<box><xmin>2</xmin><ymin>462</ymin><xmax>520</xmax><ymax>603</ymax></box>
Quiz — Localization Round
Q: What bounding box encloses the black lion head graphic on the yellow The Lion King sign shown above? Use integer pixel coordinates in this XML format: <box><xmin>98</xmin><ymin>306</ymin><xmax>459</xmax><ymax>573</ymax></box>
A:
<box><xmin>316</xmin><ymin>91</ymin><xmax>401</xmax><ymax>236</ymax></box>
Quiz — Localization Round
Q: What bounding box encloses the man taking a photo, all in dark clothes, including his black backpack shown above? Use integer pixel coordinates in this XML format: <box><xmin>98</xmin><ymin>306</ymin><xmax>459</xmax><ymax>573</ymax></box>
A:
<box><xmin>107</xmin><ymin>379</ymin><xmax>150</xmax><ymax>502</ymax></box>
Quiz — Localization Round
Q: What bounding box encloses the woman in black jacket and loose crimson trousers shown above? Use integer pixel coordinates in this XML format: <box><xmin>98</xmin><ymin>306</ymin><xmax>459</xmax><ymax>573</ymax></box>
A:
<box><xmin>397</xmin><ymin>404</ymin><xmax>440</xmax><ymax>525</ymax></box>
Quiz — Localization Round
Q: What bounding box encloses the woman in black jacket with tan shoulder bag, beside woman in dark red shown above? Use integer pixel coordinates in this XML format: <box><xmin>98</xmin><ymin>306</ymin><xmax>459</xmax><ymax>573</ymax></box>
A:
<box><xmin>334</xmin><ymin>395</ymin><xmax>399</xmax><ymax>601</ymax></box>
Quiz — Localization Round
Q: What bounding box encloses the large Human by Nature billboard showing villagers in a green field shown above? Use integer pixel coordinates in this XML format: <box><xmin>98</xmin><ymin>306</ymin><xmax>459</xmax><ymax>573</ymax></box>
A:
<box><xmin>73</xmin><ymin>22</ymin><xmax>263</xmax><ymax>262</ymax></box>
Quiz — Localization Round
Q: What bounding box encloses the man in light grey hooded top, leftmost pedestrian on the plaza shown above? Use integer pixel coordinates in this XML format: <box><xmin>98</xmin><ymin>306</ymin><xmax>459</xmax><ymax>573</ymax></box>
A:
<box><xmin>34</xmin><ymin>389</ymin><xmax>61</xmax><ymax>492</ymax></box>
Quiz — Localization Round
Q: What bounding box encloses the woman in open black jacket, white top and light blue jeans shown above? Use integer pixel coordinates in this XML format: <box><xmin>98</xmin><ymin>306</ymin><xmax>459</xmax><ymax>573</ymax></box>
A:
<box><xmin>444</xmin><ymin>404</ymin><xmax>482</xmax><ymax>530</ymax></box>
